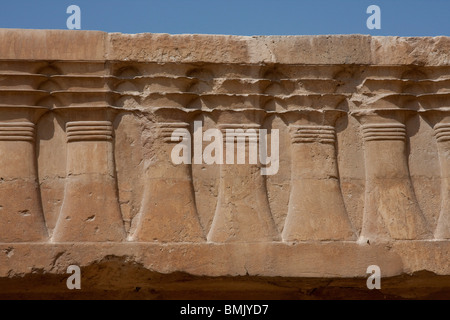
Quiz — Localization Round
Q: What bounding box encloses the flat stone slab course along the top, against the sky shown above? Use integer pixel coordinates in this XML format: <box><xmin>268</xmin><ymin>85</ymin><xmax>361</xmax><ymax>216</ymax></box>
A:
<box><xmin>0</xmin><ymin>29</ymin><xmax>450</xmax><ymax>66</ymax></box>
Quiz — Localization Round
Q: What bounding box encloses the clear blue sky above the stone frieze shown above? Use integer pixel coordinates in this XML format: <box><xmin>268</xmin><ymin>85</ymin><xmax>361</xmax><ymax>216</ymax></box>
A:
<box><xmin>0</xmin><ymin>0</ymin><xmax>450</xmax><ymax>36</ymax></box>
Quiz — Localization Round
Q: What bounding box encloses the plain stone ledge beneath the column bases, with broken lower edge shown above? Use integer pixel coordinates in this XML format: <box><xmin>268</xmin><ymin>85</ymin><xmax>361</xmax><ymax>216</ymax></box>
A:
<box><xmin>0</xmin><ymin>240</ymin><xmax>450</xmax><ymax>278</ymax></box>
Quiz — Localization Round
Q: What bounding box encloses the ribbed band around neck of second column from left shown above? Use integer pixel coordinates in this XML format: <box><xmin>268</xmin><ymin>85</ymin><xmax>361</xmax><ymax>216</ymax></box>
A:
<box><xmin>66</xmin><ymin>121</ymin><xmax>113</xmax><ymax>142</ymax></box>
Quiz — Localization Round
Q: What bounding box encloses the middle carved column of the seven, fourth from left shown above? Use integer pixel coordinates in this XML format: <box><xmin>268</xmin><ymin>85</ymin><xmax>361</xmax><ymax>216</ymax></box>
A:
<box><xmin>208</xmin><ymin>110</ymin><xmax>279</xmax><ymax>242</ymax></box>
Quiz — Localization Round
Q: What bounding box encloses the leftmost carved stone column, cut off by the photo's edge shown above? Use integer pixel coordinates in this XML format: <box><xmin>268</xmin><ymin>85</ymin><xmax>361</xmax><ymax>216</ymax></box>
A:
<box><xmin>0</xmin><ymin>106</ymin><xmax>48</xmax><ymax>242</ymax></box>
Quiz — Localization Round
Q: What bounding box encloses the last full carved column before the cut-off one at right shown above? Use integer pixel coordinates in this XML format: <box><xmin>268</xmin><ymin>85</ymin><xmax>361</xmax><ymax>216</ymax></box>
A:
<box><xmin>353</xmin><ymin>109</ymin><xmax>430</xmax><ymax>242</ymax></box>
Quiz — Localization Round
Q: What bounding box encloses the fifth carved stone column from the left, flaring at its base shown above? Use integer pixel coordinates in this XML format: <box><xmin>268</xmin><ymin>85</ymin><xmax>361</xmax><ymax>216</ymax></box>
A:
<box><xmin>282</xmin><ymin>110</ymin><xmax>355</xmax><ymax>241</ymax></box>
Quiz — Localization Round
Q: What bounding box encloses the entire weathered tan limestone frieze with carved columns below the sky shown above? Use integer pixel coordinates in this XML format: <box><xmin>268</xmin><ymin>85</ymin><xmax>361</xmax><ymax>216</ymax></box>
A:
<box><xmin>0</xmin><ymin>30</ymin><xmax>450</xmax><ymax>297</ymax></box>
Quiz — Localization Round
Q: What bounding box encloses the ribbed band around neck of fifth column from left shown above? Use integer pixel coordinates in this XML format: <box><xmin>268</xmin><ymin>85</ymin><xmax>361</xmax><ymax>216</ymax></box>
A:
<box><xmin>291</xmin><ymin>125</ymin><xmax>336</xmax><ymax>143</ymax></box>
